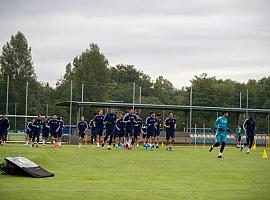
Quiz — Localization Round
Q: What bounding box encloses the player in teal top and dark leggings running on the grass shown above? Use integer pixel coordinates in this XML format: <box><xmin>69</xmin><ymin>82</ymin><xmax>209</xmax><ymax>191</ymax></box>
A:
<box><xmin>209</xmin><ymin>111</ymin><xmax>229</xmax><ymax>158</ymax></box>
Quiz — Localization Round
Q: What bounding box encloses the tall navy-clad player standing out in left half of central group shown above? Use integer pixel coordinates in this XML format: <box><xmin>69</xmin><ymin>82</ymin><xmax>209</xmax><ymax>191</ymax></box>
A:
<box><xmin>102</xmin><ymin>107</ymin><xmax>117</xmax><ymax>150</ymax></box>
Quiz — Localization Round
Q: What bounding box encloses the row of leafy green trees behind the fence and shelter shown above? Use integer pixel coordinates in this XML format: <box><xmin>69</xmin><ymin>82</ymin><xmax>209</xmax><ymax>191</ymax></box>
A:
<box><xmin>0</xmin><ymin>32</ymin><xmax>270</xmax><ymax>129</ymax></box>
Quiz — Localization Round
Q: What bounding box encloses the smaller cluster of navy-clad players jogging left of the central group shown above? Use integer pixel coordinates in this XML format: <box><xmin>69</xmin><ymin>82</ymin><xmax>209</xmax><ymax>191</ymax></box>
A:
<box><xmin>26</xmin><ymin>115</ymin><xmax>64</xmax><ymax>147</ymax></box>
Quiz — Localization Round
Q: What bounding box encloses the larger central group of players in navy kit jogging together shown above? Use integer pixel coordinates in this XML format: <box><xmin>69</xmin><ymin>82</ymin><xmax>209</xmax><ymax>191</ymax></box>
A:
<box><xmin>77</xmin><ymin>107</ymin><xmax>176</xmax><ymax>150</ymax></box>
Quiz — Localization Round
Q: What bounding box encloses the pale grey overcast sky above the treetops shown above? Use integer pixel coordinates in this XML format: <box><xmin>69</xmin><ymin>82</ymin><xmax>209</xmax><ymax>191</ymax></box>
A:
<box><xmin>0</xmin><ymin>0</ymin><xmax>270</xmax><ymax>88</ymax></box>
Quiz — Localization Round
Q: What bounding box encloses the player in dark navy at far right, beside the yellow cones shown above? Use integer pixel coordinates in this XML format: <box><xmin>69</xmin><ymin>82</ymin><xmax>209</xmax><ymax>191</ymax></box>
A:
<box><xmin>241</xmin><ymin>114</ymin><xmax>256</xmax><ymax>154</ymax></box>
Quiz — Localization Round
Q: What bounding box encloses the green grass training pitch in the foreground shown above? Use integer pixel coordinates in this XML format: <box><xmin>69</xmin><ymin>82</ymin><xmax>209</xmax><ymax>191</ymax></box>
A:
<box><xmin>0</xmin><ymin>144</ymin><xmax>270</xmax><ymax>200</ymax></box>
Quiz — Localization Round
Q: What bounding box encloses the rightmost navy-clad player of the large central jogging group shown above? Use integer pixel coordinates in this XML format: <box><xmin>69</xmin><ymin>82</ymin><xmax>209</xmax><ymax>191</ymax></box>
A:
<box><xmin>164</xmin><ymin>112</ymin><xmax>176</xmax><ymax>151</ymax></box>
